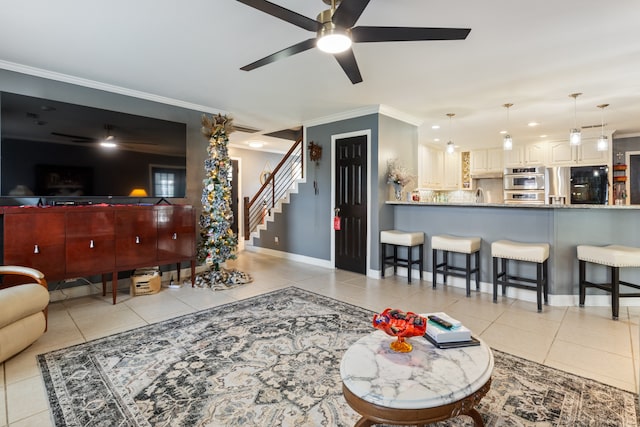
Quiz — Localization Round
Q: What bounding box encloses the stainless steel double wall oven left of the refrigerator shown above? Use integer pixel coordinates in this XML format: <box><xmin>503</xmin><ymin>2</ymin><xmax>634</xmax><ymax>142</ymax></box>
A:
<box><xmin>502</xmin><ymin>166</ymin><xmax>546</xmax><ymax>205</ymax></box>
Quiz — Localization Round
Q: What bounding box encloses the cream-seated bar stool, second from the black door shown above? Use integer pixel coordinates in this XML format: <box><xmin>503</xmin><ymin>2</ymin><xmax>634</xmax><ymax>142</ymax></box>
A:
<box><xmin>431</xmin><ymin>234</ymin><xmax>482</xmax><ymax>296</ymax></box>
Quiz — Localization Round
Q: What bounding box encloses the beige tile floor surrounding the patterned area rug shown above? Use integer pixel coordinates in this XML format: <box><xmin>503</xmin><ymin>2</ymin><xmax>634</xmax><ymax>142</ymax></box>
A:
<box><xmin>0</xmin><ymin>252</ymin><xmax>640</xmax><ymax>427</ymax></box>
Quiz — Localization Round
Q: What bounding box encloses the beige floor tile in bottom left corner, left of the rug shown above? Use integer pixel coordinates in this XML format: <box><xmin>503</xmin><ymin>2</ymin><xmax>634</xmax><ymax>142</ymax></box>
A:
<box><xmin>7</xmin><ymin>376</ymin><xmax>49</xmax><ymax>424</ymax></box>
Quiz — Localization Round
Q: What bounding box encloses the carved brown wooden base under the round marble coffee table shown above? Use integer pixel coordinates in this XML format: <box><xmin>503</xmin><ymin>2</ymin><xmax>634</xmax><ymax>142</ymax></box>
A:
<box><xmin>342</xmin><ymin>378</ymin><xmax>491</xmax><ymax>427</ymax></box>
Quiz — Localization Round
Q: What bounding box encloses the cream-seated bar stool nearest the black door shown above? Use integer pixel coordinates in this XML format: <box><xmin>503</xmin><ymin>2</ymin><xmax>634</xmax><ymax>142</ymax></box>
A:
<box><xmin>380</xmin><ymin>230</ymin><xmax>424</xmax><ymax>283</ymax></box>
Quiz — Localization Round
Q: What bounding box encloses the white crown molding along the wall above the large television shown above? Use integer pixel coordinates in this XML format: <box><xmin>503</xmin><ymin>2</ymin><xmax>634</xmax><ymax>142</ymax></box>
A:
<box><xmin>0</xmin><ymin>60</ymin><xmax>227</xmax><ymax>114</ymax></box>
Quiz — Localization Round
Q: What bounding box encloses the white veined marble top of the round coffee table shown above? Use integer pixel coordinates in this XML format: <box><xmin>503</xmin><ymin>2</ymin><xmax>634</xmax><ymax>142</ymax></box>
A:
<box><xmin>340</xmin><ymin>330</ymin><xmax>493</xmax><ymax>409</ymax></box>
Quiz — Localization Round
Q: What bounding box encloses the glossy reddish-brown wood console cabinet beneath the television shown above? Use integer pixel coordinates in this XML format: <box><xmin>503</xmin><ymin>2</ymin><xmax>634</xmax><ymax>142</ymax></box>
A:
<box><xmin>3</xmin><ymin>205</ymin><xmax>196</xmax><ymax>304</ymax></box>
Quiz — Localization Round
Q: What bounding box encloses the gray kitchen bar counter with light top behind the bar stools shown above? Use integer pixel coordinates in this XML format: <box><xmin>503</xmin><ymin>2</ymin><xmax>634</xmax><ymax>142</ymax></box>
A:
<box><xmin>381</xmin><ymin>201</ymin><xmax>640</xmax><ymax>306</ymax></box>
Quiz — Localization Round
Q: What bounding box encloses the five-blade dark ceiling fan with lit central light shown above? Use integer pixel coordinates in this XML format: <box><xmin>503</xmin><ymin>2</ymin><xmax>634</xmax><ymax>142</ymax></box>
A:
<box><xmin>237</xmin><ymin>0</ymin><xmax>471</xmax><ymax>84</ymax></box>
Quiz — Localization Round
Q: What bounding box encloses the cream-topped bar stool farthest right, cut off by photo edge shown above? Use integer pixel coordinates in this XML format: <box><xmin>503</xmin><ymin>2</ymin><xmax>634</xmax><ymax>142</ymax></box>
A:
<box><xmin>578</xmin><ymin>245</ymin><xmax>640</xmax><ymax>320</ymax></box>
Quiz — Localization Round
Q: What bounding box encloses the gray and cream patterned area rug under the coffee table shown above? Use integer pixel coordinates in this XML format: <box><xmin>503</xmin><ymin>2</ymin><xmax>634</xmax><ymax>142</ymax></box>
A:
<box><xmin>38</xmin><ymin>287</ymin><xmax>638</xmax><ymax>427</ymax></box>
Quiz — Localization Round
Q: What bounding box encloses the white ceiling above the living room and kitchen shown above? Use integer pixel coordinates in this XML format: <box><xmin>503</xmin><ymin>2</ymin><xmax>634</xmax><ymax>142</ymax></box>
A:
<box><xmin>0</xmin><ymin>0</ymin><xmax>640</xmax><ymax>154</ymax></box>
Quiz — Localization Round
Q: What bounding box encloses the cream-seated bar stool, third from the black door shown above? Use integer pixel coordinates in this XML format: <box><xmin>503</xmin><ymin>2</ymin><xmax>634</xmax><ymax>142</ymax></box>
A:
<box><xmin>491</xmin><ymin>240</ymin><xmax>549</xmax><ymax>312</ymax></box>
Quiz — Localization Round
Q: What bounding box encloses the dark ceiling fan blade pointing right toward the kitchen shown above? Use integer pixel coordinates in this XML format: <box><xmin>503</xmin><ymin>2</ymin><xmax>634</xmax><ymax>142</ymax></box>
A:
<box><xmin>351</xmin><ymin>27</ymin><xmax>471</xmax><ymax>43</ymax></box>
